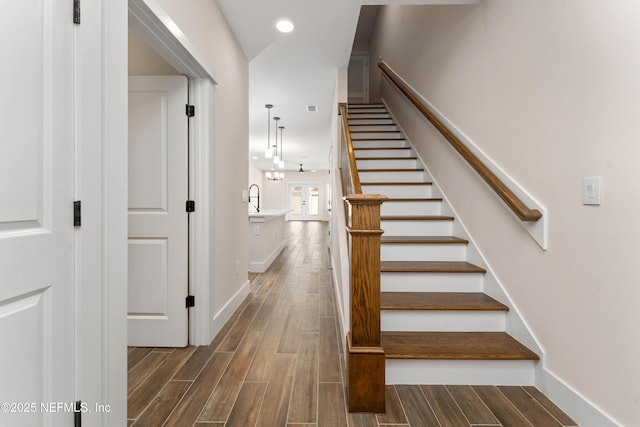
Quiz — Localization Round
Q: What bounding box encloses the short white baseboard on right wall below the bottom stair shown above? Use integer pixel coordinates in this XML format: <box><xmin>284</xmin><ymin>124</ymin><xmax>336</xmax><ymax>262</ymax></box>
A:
<box><xmin>535</xmin><ymin>364</ymin><xmax>622</xmax><ymax>427</ymax></box>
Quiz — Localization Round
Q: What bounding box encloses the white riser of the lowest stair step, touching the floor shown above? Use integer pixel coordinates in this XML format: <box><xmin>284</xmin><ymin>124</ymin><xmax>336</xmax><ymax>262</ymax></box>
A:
<box><xmin>385</xmin><ymin>359</ymin><xmax>535</xmax><ymax>386</ymax></box>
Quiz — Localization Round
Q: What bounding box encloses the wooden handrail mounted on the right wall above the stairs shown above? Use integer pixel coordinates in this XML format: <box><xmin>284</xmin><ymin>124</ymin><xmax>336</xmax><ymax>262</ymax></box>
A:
<box><xmin>378</xmin><ymin>61</ymin><xmax>542</xmax><ymax>221</ymax></box>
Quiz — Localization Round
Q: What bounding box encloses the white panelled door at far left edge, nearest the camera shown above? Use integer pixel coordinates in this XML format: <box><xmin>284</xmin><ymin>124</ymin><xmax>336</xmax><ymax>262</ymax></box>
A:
<box><xmin>0</xmin><ymin>0</ymin><xmax>76</xmax><ymax>426</ymax></box>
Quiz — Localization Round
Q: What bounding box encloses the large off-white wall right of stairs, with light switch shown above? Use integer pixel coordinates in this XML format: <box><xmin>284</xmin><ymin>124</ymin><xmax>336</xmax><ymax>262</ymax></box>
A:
<box><xmin>371</xmin><ymin>0</ymin><xmax>640</xmax><ymax>425</ymax></box>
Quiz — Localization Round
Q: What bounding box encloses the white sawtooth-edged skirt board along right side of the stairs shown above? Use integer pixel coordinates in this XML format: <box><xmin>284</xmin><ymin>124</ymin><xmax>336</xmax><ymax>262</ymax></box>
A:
<box><xmin>383</xmin><ymin>101</ymin><xmax>544</xmax><ymax>364</ymax></box>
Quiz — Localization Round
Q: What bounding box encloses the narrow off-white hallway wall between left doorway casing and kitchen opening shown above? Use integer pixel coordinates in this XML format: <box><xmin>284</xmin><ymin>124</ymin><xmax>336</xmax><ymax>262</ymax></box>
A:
<box><xmin>151</xmin><ymin>0</ymin><xmax>249</xmax><ymax>334</ymax></box>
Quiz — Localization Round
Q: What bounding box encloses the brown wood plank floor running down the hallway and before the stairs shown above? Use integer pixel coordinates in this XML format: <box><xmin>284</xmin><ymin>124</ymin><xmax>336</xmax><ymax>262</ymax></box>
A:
<box><xmin>127</xmin><ymin>222</ymin><xmax>576</xmax><ymax>427</ymax></box>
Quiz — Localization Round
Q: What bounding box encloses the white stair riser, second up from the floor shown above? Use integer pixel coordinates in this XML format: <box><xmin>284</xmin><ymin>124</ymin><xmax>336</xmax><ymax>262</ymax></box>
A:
<box><xmin>380</xmin><ymin>310</ymin><xmax>505</xmax><ymax>332</ymax></box>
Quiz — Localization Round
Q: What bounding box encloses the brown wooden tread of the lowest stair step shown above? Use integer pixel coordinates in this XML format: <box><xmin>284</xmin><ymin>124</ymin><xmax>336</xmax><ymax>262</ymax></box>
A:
<box><xmin>381</xmin><ymin>332</ymin><xmax>540</xmax><ymax>360</ymax></box>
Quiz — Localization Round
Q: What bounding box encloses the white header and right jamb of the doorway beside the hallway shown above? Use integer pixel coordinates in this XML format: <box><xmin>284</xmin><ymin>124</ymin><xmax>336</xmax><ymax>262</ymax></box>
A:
<box><xmin>129</xmin><ymin>0</ymin><xmax>216</xmax><ymax>345</ymax></box>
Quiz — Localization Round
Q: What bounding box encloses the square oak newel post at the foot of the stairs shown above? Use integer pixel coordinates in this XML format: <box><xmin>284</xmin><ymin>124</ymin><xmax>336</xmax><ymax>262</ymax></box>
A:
<box><xmin>345</xmin><ymin>194</ymin><xmax>387</xmax><ymax>412</ymax></box>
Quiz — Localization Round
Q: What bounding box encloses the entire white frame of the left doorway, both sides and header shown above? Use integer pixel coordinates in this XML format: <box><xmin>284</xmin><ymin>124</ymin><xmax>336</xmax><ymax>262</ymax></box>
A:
<box><xmin>75</xmin><ymin>0</ymin><xmax>215</xmax><ymax>427</ymax></box>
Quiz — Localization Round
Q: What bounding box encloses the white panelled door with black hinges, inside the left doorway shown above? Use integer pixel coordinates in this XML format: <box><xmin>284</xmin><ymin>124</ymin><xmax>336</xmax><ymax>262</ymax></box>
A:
<box><xmin>128</xmin><ymin>76</ymin><xmax>188</xmax><ymax>347</ymax></box>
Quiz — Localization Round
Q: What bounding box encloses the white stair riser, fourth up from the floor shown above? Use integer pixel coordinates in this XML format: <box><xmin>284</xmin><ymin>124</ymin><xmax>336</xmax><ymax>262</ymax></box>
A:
<box><xmin>380</xmin><ymin>242</ymin><xmax>467</xmax><ymax>261</ymax></box>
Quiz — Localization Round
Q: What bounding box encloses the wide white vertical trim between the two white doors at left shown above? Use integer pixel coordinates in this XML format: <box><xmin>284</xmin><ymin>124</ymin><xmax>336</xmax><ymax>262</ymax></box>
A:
<box><xmin>75</xmin><ymin>0</ymin><xmax>127</xmax><ymax>426</ymax></box>
